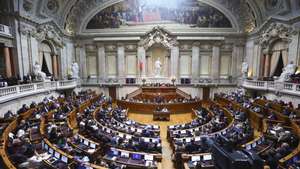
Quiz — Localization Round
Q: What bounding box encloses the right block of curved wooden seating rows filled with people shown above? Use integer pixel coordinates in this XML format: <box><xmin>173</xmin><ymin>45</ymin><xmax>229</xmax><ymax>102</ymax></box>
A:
<box><xmin>168</xmin><ymin>92</ymin><xmax>300</xmax><ymax>168</ymax></box>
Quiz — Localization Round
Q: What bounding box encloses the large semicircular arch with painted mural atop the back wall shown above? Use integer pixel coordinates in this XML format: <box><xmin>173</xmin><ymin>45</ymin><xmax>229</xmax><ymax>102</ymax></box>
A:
<box><xmin>78</xmin><ymin>0</ymin><xmax>240</xmax><ymax>32</ymax></box>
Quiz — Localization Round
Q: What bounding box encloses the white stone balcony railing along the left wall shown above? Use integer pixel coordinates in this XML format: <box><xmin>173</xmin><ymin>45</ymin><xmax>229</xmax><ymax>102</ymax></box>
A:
<box><xmin>0</xmin><ymin>80</ymin><xmax>77</xmax><ymax>103</ymax></box>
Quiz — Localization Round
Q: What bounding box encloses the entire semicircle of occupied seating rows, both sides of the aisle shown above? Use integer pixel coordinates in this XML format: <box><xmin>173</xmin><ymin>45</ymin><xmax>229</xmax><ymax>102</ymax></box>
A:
<box><xmin>0</xmin><ymin>91</ymin><xmax>300</xmax><ymax>169</ymax></box>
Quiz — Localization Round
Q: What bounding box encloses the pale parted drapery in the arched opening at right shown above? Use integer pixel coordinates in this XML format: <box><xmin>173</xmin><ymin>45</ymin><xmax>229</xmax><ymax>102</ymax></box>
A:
<box><xmin>270</xmin><ymin>42</ymin><xmax>288</xmax><ymax>77</ymax></box>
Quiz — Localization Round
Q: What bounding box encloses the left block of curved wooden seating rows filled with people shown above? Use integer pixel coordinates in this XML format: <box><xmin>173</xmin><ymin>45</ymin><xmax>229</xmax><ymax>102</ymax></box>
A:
<box><xmin>0</xmin><ymin>92</ymin><xmax>161</xmax><ymax>169</ymax></box>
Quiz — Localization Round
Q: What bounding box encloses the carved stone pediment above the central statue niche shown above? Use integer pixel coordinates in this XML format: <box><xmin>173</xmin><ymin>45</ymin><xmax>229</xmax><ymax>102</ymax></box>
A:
<box><xmin>139</xmin><ymin>26</ymin><xmax>179</xmax><ymax>50</ymax></box>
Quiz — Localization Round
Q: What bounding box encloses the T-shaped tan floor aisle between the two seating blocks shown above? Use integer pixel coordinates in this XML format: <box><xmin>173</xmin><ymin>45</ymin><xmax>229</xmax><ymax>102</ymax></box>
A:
<box><xmin>128</xmin><ymin>112</ymin><xmax>192</xmax><ymax>169</ymax></box>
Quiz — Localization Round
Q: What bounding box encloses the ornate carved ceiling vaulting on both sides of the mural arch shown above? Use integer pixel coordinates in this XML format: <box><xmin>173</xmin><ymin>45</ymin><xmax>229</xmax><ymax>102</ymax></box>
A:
<box><xmin>20</xmin><ymin>0</ymin><xmax>300</xmax><ymax>35</ymax></box>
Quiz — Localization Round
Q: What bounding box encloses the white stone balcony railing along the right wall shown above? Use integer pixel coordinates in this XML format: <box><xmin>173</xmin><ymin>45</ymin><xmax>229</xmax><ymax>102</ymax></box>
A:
<box><xmin>243</xmin><ymin>80</ymin><xmax>300</xmax><ymax>96</ymax></box>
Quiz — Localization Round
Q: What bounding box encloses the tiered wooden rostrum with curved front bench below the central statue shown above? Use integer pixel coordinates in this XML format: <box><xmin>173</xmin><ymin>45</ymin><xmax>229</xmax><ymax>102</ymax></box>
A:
<box><xmin>117</xmin><ymin>85</ymin><xmax>201</xmax><ymax>114</ymax></box>
